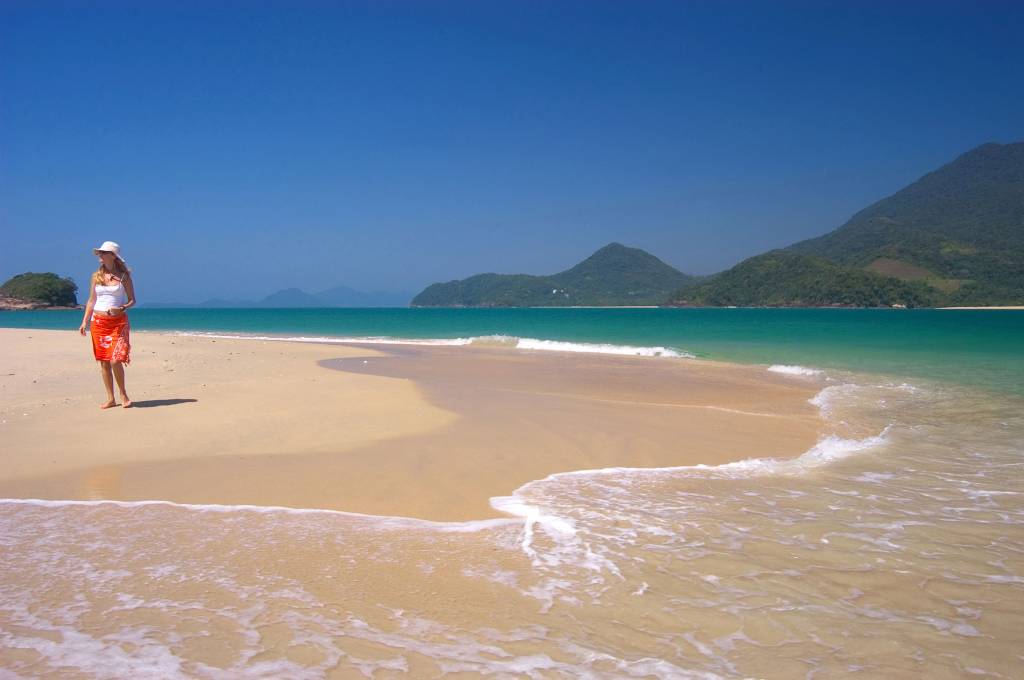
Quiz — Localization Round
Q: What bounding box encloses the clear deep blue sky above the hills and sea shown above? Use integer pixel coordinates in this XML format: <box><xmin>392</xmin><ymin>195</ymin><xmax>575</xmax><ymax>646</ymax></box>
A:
<box><xmin>0</xmin><ymin>0</ymin><xmax>1024</xmax><ymax>302</ymax></box>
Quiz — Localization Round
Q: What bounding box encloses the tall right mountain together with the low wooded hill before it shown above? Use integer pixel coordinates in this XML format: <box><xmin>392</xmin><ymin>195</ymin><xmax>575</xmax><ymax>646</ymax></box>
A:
<box><xmin>669</xmin><ymin>143</ymin><xmax>1024</xmax><ymax>306</ymax></box>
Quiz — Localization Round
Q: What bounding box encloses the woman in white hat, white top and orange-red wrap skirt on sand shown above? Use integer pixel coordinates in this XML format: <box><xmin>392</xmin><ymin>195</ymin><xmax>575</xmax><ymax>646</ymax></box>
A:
<box><xmin>78</xmin><ymin>241</ymin><xmax>135</xmax><ymax>409</ymax></box>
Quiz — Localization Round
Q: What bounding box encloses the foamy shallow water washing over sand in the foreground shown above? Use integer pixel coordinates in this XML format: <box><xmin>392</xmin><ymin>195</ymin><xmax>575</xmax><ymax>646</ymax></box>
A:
<box><xmin>0</xmin><ymin>359</ymin><xmax>1024</xmax><ymax>678</ymax></box>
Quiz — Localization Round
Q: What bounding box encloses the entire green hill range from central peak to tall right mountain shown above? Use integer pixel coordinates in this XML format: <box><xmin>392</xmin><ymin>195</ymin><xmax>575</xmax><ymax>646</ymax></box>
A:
<box><xmin>413</xmin><ymin>142</ymin><xmax>1024</xmax><ymax>307</ymax></box>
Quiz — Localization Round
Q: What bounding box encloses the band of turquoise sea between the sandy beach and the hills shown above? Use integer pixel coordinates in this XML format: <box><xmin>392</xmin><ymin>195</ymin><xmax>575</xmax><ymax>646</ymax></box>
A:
<box><xmin>0</xmin><ymin>308</ymin><xmax>1024</xmax><ymax>393</ymax></box>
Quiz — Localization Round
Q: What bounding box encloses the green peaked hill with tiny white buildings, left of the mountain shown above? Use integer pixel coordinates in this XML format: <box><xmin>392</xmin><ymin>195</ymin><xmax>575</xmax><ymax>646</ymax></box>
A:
<box><xmin>412</xmin><ymin>243</ymin><xmax>693</xmax><ymax>307</ymax></box>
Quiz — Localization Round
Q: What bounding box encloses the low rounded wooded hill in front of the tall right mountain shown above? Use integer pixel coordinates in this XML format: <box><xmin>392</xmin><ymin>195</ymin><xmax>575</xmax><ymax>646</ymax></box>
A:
<box><xmin>671</xmin><ymin>250</ymin><xmax>936</xmax><ymax>307</ymax></box>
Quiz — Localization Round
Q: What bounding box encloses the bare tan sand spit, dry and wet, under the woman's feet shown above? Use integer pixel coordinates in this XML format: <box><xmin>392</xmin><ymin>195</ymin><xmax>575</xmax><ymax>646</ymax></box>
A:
<box><xmin>0</xmin><ymin>329</ymin><xmax>823</xmax><ymax>521</ymax></box>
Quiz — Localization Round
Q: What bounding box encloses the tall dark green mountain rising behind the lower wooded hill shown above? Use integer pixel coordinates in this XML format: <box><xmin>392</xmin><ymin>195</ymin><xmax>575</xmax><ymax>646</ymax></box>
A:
<box><xmin>786</xmin><ymin>142</ymin><xmax>1024</xmax><ymax>304</ymax></box>
